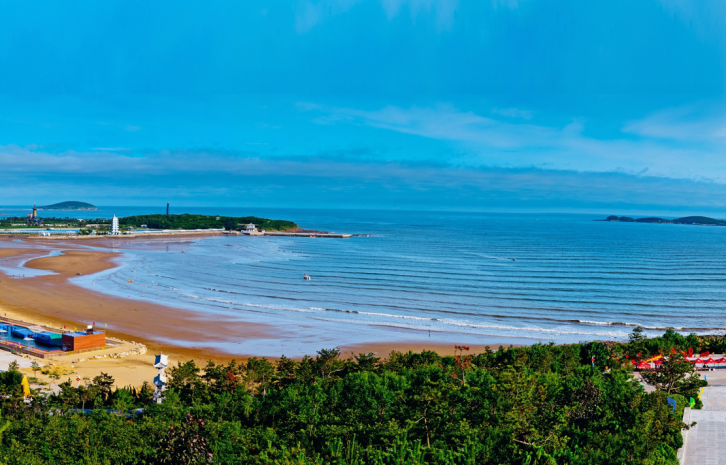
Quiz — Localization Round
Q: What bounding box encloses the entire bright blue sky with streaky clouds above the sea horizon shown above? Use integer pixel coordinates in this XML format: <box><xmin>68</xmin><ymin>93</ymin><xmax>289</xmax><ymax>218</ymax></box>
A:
<box><xmin>0</xmin><ymin>0</ymin><xmax>726</xmax><ymax>212</ymax></box>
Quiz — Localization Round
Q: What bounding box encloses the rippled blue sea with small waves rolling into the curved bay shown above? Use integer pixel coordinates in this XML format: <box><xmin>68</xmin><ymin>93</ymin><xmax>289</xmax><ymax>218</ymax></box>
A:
<box><xmin>0</xmin><ymin>207</ymin><xmax>726</xmax><ymax>355</ymax></box>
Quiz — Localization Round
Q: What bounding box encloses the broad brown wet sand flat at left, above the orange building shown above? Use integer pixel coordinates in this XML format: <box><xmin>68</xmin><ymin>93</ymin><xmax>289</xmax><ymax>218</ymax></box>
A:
<box><xmin>0</xmin><ymin>245</ymin><xmax>274</xmax><ymax>360</ymax></box>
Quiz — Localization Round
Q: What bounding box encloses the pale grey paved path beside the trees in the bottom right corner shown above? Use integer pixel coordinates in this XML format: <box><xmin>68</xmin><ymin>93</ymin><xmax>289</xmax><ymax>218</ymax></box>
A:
<box><xmin>681</xmin><ymin>370</ymin><xmax>726</xmax><ymax>465</ymax></box>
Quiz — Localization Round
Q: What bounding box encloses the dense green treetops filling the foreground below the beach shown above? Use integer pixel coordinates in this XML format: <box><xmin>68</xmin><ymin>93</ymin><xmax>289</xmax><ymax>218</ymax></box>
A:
<box><xmin>0</xmin><ymin>331</ymin><xmax>712</xmax><ymax>465</ymax></box>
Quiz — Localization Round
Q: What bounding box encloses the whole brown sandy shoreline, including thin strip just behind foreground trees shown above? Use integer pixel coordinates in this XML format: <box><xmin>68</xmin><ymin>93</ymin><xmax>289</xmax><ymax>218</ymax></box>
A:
<box><xmin>0</xmin><ymin>238</ymin><xmax>520</xmax><ymax>362</ymax></box>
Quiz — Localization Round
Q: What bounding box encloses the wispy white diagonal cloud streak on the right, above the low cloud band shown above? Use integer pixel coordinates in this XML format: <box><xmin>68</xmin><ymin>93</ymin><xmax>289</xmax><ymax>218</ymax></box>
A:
<box><xmin>300</xmin><ymin>104</ymin><xmax>726</xmax><ymax>182</ymax></box>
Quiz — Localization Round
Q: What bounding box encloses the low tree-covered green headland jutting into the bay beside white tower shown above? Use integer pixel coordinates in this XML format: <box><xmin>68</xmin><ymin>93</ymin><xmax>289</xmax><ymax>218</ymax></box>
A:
<box><xmin>119</xmin><ymin>214</ymin><xmax>298</xmax><ymax>231</ymax></box>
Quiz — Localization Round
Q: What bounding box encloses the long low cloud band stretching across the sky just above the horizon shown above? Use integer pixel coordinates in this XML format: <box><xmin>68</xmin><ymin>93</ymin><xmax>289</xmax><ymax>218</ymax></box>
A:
<box><xmin>0</xmin><ymin>146</ymin><xmax>726</xmax><ymax>211</ymax></box>
